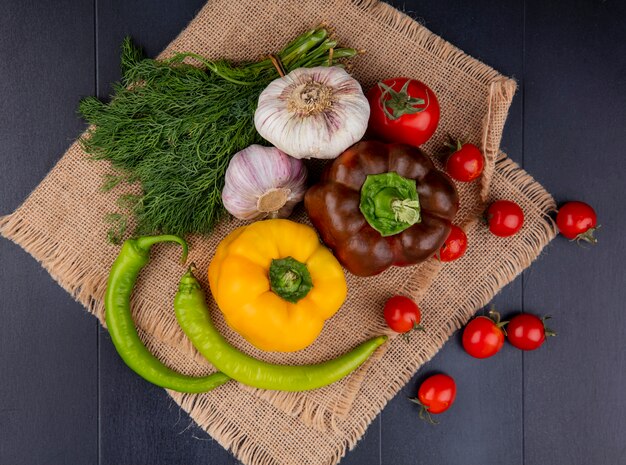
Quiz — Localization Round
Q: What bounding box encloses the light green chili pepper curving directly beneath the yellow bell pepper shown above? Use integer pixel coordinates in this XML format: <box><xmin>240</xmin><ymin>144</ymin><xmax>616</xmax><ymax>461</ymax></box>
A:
<box><xmin>174</xmin><ymin>268</ymin><xmax>387</xmax><ymax>391</ymax></box>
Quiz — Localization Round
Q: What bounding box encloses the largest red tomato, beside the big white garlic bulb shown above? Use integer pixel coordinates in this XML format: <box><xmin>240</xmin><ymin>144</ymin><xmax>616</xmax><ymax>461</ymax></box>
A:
<box><xmin>367</xmin><ymin>78</ymin><xmax>439</xmax><ymax>147</ymax></box>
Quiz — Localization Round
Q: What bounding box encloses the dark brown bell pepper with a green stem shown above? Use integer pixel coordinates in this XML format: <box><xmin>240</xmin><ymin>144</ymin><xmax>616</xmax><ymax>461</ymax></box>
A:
<box><xmin>304</xmin><ymin>141</ymin><xmax>459</xmax><ymax>276</ymax></box>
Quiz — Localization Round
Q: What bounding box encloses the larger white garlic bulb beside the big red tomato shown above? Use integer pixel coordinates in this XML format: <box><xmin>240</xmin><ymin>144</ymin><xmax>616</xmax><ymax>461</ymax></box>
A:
<box><xmin>254</xmin><ymin>66</ymin><xmax>370</xmax><ymax>159</ymax></box>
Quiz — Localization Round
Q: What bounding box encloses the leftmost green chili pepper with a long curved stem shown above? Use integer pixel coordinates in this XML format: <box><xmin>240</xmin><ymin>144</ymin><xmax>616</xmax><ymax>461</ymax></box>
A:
<box><xmin>104</xmin><ymin>235</ymin><xmax>230</xmax><ymax>392</ymax></box>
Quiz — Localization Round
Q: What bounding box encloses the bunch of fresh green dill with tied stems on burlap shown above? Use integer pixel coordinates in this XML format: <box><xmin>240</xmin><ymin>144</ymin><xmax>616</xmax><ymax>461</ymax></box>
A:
<box><xmin>79</xmin><ymin>27</ymin><xmax>357</xmax><ymax>242</ymax></box>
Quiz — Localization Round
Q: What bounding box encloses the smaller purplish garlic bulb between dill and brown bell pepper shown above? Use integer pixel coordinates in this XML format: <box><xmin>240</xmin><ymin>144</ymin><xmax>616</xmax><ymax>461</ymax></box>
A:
<box><xmin>222</xmin><ymin>144</ymin><xmax>307</xmax><ymax>221</ymax></box>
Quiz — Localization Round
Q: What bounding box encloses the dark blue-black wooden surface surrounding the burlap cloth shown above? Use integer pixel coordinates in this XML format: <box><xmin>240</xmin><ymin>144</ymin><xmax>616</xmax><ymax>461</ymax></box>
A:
<box><xmin>0</xmin><ymin>0</ymin><xmax>626</xmax><ymax>465</ymax></box>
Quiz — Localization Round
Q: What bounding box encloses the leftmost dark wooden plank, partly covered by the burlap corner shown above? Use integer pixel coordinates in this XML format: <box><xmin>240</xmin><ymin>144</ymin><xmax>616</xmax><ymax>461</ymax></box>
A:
<box><xmin>0</xmin><ymin>1</ymin><xmax>98</xmax><ymax>465</ymax></box>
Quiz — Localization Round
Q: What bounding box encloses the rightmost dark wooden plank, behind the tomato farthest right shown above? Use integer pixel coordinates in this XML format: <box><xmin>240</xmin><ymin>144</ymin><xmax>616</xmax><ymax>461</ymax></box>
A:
<box><xmin>524</xmin><ymin>0</ymin><xmax>626</xmax><ymax>465</ymax></box>
